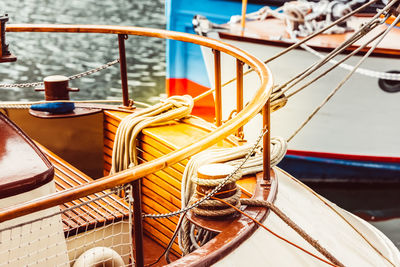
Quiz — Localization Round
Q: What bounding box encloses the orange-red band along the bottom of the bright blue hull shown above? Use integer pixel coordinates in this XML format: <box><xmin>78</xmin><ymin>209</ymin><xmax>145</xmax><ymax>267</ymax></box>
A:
<box><xmin>166</xmin><ymin>78</ymin><xmax>215</xmax><ymax>122</ymax></box>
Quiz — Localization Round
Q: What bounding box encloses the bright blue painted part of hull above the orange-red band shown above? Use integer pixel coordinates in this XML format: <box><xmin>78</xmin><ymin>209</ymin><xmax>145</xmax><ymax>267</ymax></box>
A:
<box><xmin>165</xmin><ymin>0</ymin><xmax>263</xmax><ymax>87</ymax></box>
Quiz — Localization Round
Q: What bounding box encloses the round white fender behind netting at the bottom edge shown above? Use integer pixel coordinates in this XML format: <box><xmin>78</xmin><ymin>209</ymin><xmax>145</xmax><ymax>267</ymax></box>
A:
<box><xmin>73</xmin><ymin>247</ymin><xmax>125</xmax><ymax>267</ymax></box>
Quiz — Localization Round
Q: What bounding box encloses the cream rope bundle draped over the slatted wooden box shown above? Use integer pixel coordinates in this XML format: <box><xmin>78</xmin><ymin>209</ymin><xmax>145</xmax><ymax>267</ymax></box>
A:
<box><xmin>110</xmin><ymin>95</ymin><xmax>193</xmax><ymax>174</ymax></box>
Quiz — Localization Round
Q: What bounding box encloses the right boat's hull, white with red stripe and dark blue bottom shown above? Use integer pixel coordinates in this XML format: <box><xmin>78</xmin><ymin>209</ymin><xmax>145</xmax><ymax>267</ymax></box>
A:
<box><xmin>199</xmin><ymin>35</ymin><xmax>400</xmax><ymax>182</ymax></box>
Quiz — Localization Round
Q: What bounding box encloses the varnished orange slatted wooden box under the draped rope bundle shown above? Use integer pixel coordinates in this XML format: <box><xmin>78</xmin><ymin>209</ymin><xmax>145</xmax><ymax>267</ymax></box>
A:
<box><xmin>104</xmin><ymin>111</ymin><xmax>241</xmax><ymax>255</ymax></box>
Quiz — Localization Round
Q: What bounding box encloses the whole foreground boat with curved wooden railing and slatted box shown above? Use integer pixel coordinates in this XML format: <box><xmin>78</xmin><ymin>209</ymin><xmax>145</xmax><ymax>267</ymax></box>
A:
<box><xmin>0</xmin><ymin>14</ymin><xmax>400</xmax><ymax>266</ymax></box>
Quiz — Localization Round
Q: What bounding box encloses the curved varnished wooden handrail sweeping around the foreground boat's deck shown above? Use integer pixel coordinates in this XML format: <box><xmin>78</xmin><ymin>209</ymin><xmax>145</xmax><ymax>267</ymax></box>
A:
<box><xmin>0</xmin><ymin>24</ymin><xmax>272</xmax><ymax>222</ymax></box>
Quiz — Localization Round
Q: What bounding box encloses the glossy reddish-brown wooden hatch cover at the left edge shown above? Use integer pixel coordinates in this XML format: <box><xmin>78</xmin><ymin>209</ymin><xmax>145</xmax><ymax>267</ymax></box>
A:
<box><xmin>0</xmin><ymin>113</ymin><xmax>54</xmax><ymax>199</ymax></box>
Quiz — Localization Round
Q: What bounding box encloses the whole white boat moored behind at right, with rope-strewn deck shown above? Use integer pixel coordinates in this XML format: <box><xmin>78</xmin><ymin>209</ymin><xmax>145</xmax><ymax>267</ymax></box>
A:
<box><xmin>166</xmin><ymin>1</ymin><xmax>400</xmax><ymax>183</ymax></box>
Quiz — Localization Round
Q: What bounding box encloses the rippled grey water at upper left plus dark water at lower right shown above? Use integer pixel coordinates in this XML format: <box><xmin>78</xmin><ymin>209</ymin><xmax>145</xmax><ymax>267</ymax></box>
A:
<box><xmin>0</xmin><ymin>0</ymin><xmax>400</xmax><ymax>253</ymax></box>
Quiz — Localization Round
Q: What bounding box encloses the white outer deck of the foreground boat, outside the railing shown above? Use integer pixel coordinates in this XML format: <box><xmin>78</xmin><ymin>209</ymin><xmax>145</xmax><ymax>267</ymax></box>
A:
<box><xmin>214</xmin><ymin>169</ymin><xmax>400</xmax><ymax>266</ymax></box>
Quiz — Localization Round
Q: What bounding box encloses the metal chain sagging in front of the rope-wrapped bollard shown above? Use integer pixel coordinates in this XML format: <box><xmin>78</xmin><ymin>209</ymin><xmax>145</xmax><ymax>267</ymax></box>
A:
<box><xmin>143</xmin><ymin>130</ymin><xmax>267</xmax><ymax>219</ymax></box>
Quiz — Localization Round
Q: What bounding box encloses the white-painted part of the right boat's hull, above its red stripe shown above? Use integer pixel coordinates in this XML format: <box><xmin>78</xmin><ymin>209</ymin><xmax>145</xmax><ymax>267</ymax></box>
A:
<box><xmin>203</xmin><ymin>39</ymin><xmax>400</xmax><ymax>157</ymax></box>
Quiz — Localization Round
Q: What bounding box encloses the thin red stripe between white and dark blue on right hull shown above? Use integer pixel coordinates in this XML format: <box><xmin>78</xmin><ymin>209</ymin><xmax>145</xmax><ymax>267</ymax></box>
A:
<box><xmin>287</xmin><ymin>150</ymin><xmax>400</xmax><ymax>163</ymax></box>
